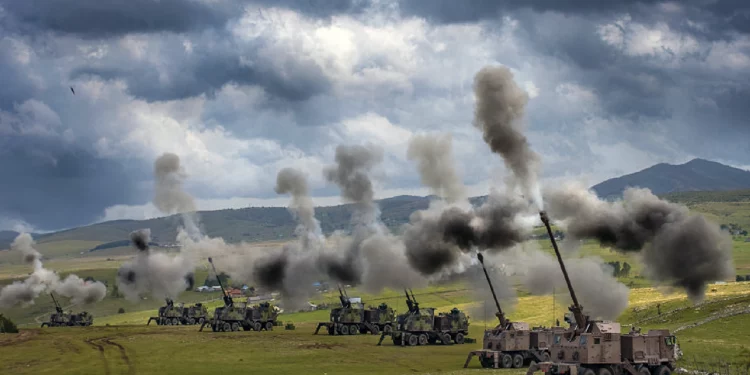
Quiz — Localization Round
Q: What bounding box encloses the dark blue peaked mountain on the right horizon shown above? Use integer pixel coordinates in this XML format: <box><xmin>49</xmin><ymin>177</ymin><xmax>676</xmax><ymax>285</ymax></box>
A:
<box><xmin>591</xmin><ymin>159</ymin><xmax>750</xmax><ymax>199</ymax></box>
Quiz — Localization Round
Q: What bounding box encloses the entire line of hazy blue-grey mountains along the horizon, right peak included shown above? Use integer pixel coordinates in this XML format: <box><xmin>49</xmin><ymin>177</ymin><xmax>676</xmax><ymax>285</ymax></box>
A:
<box><xmin>5</xmin><ymin>159</ymin><xmax>750</xmax><ymax>251</ymax></box>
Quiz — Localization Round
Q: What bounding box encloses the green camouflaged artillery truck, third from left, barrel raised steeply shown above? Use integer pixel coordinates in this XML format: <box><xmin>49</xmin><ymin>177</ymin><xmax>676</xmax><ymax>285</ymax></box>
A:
<box><xmin>199</xmin><ymin>258</ymin><xmax>278</xmax><ymax>332</ymax></box>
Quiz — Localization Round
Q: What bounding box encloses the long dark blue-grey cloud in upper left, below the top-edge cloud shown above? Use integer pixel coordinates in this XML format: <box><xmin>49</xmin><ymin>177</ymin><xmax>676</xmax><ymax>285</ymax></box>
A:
<box><xmin>70</xmin><ymin>29</ymin><xmax>331</xmax><ymax>103</ymax></box>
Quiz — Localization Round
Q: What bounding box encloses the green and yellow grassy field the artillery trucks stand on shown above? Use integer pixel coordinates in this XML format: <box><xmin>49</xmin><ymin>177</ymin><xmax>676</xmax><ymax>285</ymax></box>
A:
<box><xmin>0</xmin><ymin>283</ymin><xmax>750</xmax><ymax>374</ymax></box>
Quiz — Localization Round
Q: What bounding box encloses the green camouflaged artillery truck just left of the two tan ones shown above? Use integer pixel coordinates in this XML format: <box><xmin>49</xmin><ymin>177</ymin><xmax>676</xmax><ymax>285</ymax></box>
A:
<box><xmin>378</xmin><ymin>289</ymin><xmax>469</xmax><ymax>346</ymax></box>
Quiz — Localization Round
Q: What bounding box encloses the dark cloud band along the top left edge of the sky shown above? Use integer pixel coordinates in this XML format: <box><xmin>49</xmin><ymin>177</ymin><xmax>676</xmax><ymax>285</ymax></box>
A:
<box><xmin>0</xmin><ymin>0</ymin><xmax>369</xmax><ymax>38</ymax></box>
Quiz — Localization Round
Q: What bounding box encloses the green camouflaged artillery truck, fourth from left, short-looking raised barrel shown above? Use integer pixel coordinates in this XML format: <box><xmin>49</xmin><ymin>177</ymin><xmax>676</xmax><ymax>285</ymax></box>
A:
<box><xmin>314</xmin><ymin>286</ymin><xmax>395</xmax><ymax>335</ymax></box>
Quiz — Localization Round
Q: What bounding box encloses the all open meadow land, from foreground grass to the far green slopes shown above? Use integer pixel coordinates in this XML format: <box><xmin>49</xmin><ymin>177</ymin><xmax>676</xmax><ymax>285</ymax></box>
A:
<box><xmin>0</xmin><ymin>195</ymin><xmax>750</xmax><ymax>374</ymax></box>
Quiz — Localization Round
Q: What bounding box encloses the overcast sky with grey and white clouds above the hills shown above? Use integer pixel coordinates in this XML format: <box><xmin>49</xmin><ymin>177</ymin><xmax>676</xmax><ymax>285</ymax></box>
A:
<box><xmin>0</xmin><ymin>0</ymin><xmax>750</xmax><ymax>230</ymax></box>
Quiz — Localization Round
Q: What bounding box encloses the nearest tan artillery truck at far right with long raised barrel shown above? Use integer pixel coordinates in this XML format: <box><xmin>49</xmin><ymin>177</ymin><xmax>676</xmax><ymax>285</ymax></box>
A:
<box><xmin>527</xmin><ymin>212</ymin><xmax>677</xmax><ymax>375</ymax></box>
